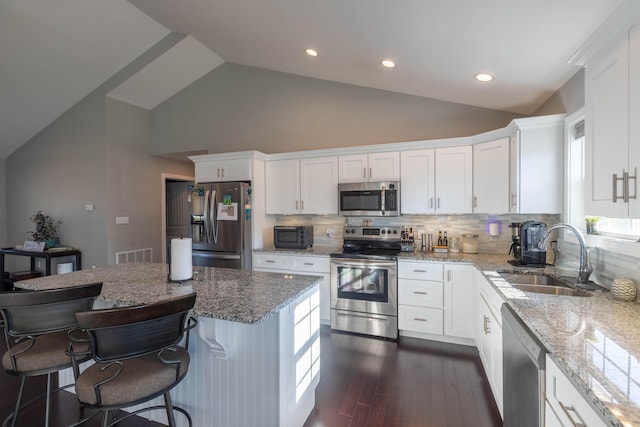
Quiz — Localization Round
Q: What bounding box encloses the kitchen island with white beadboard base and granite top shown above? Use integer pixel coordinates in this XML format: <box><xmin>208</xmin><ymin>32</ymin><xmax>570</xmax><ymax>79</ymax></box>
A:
<box><xmin>17</xmin><ymin>263</ymin><xmax>321</xmax><ymax>427</ymax></box>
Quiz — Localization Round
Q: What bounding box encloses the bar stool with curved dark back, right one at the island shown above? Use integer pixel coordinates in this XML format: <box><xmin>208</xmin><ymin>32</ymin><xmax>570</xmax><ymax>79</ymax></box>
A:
<box><xmin>74</xmin><ymin>294</ymin><xmax>196</xmax><ymax>426</ymax></box>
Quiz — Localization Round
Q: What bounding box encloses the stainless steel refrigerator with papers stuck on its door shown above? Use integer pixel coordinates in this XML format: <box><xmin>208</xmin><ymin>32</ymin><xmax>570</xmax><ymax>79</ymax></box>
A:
<box><xmin>189</xmin><ymin>182</ymin><xmax>251</xmax><ymax>270</ymax></box>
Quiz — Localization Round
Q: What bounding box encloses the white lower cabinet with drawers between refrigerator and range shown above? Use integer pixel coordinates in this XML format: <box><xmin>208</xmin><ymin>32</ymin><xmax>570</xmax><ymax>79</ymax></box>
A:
<box><xmin>252</xmin><ymin>253</ymin><xmax>331</xmax><ymax>324</ymax></box>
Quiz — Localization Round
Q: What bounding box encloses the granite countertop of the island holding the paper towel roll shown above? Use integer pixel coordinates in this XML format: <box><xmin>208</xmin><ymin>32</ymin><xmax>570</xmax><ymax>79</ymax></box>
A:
<box><xmin>16</xmin><ymin>263</ymin><xmax>322</xmax><ymax>323</ymax></box>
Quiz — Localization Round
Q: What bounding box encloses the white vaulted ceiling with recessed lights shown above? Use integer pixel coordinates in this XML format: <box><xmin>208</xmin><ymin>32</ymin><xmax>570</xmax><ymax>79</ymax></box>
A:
<box><xmin>0</xmin><ymin>0</ymin><xmax>629</xmax><ymax>158</ymax></box>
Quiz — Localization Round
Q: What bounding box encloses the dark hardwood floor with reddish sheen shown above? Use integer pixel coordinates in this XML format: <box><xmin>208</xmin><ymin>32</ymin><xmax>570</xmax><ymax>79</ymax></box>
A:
<box><xmin>0</xmin><ymin>326</ymin><xmax>502</xmax><ymax>427</ymax></box>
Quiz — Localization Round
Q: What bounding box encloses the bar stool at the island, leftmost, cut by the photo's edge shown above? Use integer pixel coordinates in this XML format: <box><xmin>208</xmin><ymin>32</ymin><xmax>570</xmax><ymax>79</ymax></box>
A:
<box><xmin>0</xmin><ymin>283</ymin><xmax>102</xmax><ymax>426</ymax></box>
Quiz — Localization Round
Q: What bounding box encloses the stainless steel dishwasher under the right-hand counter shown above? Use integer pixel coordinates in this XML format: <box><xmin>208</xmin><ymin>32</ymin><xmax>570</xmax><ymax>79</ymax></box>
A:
<box><xmin>500</xmin><ymin>304</ymin><xmax>547</xmax><ymax>427</ymax></box>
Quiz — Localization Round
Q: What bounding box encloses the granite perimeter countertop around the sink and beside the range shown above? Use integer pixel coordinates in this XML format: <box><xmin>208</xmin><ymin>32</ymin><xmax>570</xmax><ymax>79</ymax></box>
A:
<box><xmin>256</xmin><ymin>248</ymin><xmax>640</xmax><ymax>427</ymax></box>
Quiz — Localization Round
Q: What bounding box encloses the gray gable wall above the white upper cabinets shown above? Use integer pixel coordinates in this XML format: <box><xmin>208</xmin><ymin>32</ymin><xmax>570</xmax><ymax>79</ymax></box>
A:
<box><xmin>151</xmin><ymin>63</ymin><xmax>519</xmax><ymax>153</ymax></box>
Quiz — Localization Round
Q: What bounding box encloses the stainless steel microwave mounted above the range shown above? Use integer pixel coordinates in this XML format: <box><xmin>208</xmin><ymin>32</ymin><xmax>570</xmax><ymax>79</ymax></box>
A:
<box><xmin>338</xmin><ymin>181</ymin><xmax>400</xmax><ymax>216</ymax></box>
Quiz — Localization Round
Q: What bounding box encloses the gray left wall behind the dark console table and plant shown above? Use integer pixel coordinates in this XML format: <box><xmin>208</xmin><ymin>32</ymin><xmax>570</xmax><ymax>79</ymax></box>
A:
<box><xmin>6</xmin><ymin>34</ymin><xmax>193</xmax><ymax>270</ymax></box>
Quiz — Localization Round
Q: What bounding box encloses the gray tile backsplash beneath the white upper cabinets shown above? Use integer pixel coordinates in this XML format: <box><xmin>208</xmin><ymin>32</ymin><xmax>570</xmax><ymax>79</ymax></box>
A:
<box><xmin>276</xmin><ymin>214</ymin><xmax>561</xmax><ymax>256</ymax></box>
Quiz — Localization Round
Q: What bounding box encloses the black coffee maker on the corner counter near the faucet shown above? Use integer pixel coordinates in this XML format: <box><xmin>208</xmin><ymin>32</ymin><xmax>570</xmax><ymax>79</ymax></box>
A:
<box><xmin>509</xmin><ymin>221</ymin><xmax>547</xmax><ymax>267</ymax></box>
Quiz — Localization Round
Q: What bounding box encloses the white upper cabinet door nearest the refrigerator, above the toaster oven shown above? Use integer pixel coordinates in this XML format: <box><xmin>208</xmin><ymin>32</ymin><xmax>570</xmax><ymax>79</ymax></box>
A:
<box><xmin>266</xmin><ymin>160</ymin><xmax>300</xmax><ymax>215</ymax></box>
